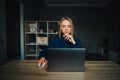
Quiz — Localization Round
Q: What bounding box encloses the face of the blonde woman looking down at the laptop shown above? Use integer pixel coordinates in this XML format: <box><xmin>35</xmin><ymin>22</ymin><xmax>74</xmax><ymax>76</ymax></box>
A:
<box><xmin>60</xmin><ymin>20</ymin><xmax>72</xmax><ymax>35</ymax></box>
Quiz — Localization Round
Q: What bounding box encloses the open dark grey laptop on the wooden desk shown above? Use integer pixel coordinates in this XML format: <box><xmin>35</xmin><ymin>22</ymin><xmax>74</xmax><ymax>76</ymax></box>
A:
<box><xmin>47</xmin><ymin>48</ymin><xmax>86</xmax><ymax>72</ymax></box>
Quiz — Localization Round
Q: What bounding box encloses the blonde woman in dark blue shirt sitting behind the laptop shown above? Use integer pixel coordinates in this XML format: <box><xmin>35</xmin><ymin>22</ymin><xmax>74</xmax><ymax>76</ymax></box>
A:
<box><xmin>38</xmin><ymin>17</ymin><xmax>82</xmax><ymax>65</ymax></box>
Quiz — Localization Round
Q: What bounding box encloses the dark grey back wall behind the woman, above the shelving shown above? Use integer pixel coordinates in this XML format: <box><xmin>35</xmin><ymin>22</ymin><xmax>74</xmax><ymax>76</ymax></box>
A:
<box><xmin>39</xmin><ymin>7</ymin><xmax>106</xmax><ymax>53</ymax></box>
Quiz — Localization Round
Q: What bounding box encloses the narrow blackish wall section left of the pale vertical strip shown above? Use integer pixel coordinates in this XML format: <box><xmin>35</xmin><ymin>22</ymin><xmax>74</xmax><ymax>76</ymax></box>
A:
<box><xmin>6</xmin><ymin>0</ymin><xmax>20</xmax><ymax>60</ymax></box>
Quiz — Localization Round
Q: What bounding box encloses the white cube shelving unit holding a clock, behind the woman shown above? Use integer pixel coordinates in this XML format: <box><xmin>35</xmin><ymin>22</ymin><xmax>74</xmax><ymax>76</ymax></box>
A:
<box><xmin>24</xmin><ymin>21</ymin><xmax>58</xmax><ymax>59</ymax></box>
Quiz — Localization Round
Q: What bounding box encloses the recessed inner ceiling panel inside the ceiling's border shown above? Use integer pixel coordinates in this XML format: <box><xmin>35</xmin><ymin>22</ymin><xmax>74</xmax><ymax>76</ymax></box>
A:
<box><xmin>44</xmin><ymin>0</ymin><xmax>113</xmax><ymax>6</ymax></box>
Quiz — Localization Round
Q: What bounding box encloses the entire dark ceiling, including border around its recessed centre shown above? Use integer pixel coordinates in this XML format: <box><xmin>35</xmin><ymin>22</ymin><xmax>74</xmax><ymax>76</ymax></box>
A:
<box><xmin>17</xmin><ymin>0</ymin><xmax>115</xmax><ymax>7</ymax></box>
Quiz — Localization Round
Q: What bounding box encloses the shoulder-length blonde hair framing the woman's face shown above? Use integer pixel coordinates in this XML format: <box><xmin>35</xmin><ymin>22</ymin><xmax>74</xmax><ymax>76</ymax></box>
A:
<box><xmin>58</xmin><ymin>17</ymin><xmax>75</xmax><ymax>38</ymax></box>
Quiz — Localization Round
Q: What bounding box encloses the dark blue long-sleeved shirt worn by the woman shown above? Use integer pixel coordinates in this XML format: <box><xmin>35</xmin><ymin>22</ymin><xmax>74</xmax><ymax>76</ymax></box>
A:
<box><xmin>38</xmin><ymin>36</ymin><xmax>83</xmax><ymax>59</ymax></box>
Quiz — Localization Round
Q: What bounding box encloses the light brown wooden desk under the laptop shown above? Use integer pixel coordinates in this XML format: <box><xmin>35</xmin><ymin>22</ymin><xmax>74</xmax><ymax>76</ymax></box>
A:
<box><xmin>0</xmin><ymin>60</ymin><xmax>120</xmax><ymax>80</ymax></box>
